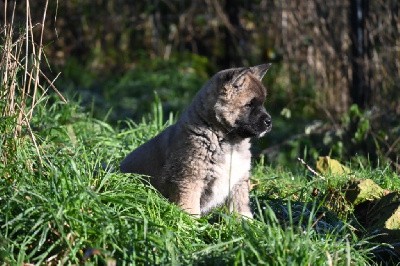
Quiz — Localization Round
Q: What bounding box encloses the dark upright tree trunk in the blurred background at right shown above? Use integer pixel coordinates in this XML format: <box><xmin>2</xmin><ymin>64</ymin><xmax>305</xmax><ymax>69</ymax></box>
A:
<box><xmin>349</xmin><ymin>0</ymin><xmax>371</xmax><ymax>109</ymax></box>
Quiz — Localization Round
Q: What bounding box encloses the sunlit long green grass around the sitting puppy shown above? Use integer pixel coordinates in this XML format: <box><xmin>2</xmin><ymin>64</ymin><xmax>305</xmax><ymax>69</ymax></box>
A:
<box><xmin>0</xmin><ymin>96</ymin><xmax>398</xmax><ymax>265</ymax></box>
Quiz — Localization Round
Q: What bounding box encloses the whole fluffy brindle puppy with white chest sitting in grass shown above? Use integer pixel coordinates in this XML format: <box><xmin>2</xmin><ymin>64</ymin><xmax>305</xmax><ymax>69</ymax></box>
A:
<box><xmin>120</xmin><ymin>64</ymin><xmax>271</xmax><ymax>217</ymax></box>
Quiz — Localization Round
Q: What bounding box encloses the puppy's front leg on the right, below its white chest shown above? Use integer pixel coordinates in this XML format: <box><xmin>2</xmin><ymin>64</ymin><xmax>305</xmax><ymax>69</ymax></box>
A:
<box><xmin>227</xmin><ymin>177</ymin><xmax>253</xmax><ymax>218</ymax></box>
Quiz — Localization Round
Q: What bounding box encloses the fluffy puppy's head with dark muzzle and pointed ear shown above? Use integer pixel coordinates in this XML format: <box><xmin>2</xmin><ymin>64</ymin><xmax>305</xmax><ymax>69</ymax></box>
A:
<box><xmin>214</xmin><ymin>64</ymin><xmax>272</xmax><ymax>138</ymax></box>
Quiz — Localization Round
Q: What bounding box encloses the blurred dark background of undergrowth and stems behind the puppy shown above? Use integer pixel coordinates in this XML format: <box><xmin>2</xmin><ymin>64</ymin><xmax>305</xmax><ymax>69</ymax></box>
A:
<box><xmin>0</xmin><ymin>0</ymin><xmax>400</xmax><ymax>170</ymax></box>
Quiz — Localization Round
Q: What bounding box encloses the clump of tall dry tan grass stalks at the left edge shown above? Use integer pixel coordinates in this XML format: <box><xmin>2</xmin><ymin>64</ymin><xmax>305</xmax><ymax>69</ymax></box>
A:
<box><xmin>0</xmin><ymin>0</ymin><xmax>66</xmax><ymax>165</ymax></box>
